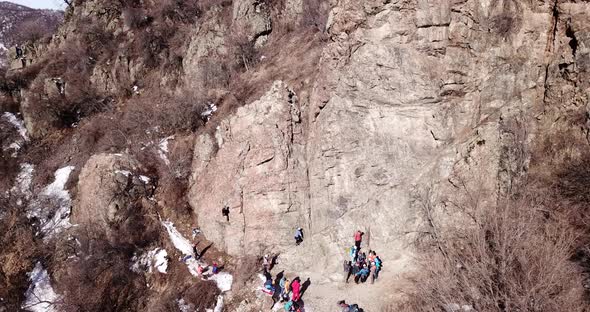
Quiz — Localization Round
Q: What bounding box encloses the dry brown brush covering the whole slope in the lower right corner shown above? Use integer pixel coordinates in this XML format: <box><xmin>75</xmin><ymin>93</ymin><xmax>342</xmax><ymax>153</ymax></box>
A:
<box><xmin>392</xmin><ymin>150</ymin><xmax>590</xmax><ymax>311</ymax></box>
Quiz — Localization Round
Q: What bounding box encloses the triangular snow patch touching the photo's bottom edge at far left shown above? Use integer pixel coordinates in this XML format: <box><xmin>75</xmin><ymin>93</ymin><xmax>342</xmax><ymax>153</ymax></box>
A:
<box><xmin>22</xmin><ymin>262</ymin><xmax>59</xmax><ymax>312</ymax></box>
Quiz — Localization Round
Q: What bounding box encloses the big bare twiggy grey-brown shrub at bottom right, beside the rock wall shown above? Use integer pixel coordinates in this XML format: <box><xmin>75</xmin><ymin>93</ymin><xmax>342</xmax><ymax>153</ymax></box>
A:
<box><xmin>398</xmin><ymin>193</ymin><xmax>584</xmax><ymax>311</ymax></box>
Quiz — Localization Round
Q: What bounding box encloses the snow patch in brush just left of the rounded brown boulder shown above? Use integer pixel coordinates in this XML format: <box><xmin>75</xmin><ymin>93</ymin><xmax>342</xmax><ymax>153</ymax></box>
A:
<box><xmin>27</xmin><ymin>166</ymin><xmax>75</xmax><ymax>239</ymax></box>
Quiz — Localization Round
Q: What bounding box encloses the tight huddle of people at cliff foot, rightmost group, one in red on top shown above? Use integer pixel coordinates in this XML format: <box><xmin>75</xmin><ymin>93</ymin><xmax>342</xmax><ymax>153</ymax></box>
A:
<box><xmin>343</xmin><ymin>231</ymin><xmax>383</xmax><ymax>284</ymax></box>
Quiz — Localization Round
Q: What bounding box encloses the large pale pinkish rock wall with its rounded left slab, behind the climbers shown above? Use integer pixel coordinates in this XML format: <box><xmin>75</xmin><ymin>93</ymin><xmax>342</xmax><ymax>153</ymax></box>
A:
<box><xmin>190</xmin><ymin>0</ymin><xmax>589</xmax><ymax>292</ymax></box>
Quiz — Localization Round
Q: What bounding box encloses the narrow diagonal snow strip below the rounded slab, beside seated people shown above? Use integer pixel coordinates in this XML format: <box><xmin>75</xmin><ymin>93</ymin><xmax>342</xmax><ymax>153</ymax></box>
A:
<box><xmin>162</xmin><ymin>221</ymin><xmax>233</xmax><ymax>292</ymax></box>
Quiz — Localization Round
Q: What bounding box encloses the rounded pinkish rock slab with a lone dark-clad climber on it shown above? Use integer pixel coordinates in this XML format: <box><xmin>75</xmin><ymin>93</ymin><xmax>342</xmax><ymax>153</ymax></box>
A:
<box><xmin>189</xmin><ymin>82</ymin><xmax>308</xmax><ymax>255</ymax></box>
